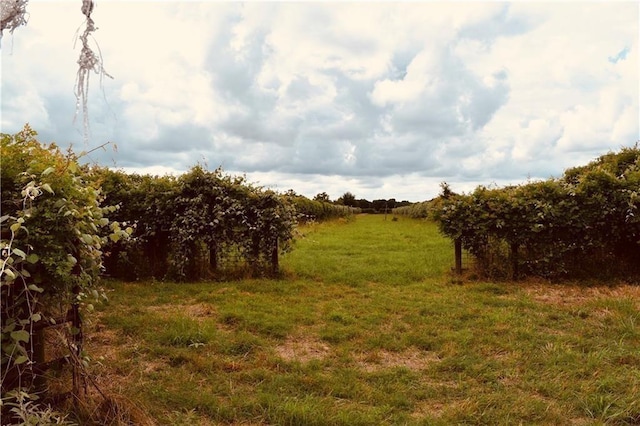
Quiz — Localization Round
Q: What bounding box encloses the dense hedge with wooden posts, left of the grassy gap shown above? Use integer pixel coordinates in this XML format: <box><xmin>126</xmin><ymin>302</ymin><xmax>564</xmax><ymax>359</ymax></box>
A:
<box><xmin>98</xmin><ymin>166</ymin><xmax>297</xmax><ymax>281</ymax></box>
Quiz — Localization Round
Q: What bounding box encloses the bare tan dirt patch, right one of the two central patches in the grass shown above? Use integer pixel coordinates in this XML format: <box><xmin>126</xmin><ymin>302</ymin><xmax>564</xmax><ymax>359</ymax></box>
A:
<box><xmin>356</xmin><ymin>348</ymin><xmax>440</xmax><ymax>373</ymax></box>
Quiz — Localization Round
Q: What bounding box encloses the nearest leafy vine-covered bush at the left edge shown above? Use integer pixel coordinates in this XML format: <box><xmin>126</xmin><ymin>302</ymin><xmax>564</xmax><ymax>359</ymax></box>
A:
<box><xmin>0</xmin><ymin>125</ymin><xmax>128</xmax><ymax>414</ymax></box>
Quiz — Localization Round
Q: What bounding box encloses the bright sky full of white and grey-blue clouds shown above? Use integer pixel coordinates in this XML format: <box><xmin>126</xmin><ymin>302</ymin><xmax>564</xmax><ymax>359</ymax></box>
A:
<box><xmin>1</xmin><ymin>0</ymin><xmax>640</xmax><ymax>201</ymax></box>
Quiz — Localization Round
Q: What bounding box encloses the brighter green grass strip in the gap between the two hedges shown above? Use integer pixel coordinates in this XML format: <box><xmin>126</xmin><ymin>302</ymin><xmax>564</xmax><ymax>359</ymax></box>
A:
<box><xmin>283</xmin><ymin>215</ymin><xmax>453</xmax><ymax>285</ymax></box>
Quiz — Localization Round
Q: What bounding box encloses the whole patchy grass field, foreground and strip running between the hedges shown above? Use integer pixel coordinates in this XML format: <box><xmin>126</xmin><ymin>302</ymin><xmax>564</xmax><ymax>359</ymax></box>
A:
<box><xmin>87</xmin><ymin>216</ymin><xmax>640</xmax><ymax>425</ymax></box>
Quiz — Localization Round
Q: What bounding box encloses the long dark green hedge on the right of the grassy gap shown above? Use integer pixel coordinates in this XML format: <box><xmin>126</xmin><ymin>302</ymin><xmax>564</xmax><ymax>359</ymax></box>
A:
<box><xmin>434</xmin><ymin>145</ymin><xmax>640</xmax><ymax>278</ymax></box>
